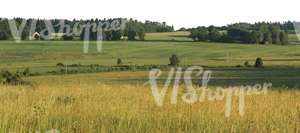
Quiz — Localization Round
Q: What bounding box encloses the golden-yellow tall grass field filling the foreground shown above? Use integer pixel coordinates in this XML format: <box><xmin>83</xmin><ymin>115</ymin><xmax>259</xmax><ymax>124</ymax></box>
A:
<box><xmin>0</xmin><ymin>74</ymin><xmax>300</xmax><ymax>133</ymax></box>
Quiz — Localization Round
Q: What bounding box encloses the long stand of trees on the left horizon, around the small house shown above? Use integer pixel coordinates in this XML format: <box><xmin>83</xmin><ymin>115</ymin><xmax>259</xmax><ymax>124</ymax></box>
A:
<box><xmin>0</xmin><ymin>18</ymin><xmax>174</xmax><ymax>40</ymax></box>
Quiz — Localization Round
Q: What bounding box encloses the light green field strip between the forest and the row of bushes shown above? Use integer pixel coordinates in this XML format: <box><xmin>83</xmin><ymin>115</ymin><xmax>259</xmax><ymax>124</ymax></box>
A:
<box><xmin>0</xmin><ymin>41</ymin><xmax>300</xmax><ymax>68</ymax></box>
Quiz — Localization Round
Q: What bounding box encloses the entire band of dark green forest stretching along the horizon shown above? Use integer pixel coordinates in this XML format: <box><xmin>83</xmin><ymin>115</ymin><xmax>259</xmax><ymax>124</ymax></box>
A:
<box><xmin>0</xmin><ymin>18</ymin><xmax>295</xmax><ymax>45</ymax></box>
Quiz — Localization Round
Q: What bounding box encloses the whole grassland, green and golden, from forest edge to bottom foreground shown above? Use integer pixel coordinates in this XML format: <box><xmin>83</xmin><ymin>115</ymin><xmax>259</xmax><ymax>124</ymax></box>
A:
<box><xmin>0</xmin><ymin>32</ymin><xmax>300</xmax><ymax>133</ymax></box>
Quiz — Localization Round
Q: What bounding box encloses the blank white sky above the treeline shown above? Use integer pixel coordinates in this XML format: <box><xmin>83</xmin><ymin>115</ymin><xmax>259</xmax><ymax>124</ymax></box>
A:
<box><xmin>0</xmin><ymin>0</ymin><xmax>300</xmax><ymax>29</ymax></box>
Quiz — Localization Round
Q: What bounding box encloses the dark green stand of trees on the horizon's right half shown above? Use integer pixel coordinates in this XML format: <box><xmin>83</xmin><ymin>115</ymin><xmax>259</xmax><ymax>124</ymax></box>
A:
<box><xmin>190</xmin><ymin>22</ymin><xmax>293</xmax><ymax>45</ymax></box>
